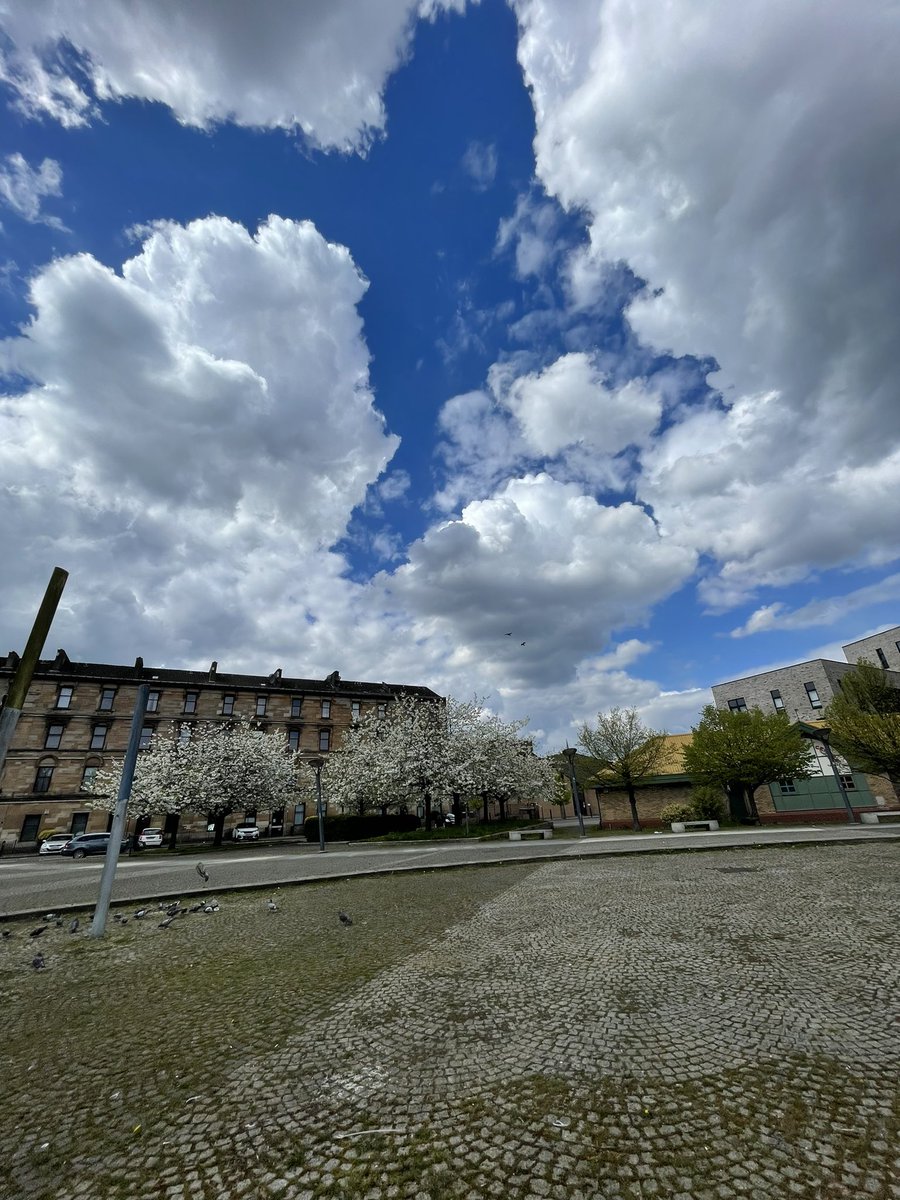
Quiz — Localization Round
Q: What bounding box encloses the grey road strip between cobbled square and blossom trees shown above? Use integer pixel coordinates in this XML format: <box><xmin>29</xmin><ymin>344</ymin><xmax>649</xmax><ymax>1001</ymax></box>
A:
<box><xmin>0</xmin><ymin>826</ymin><xmax>900</xmax><ymax>919</ymax></box>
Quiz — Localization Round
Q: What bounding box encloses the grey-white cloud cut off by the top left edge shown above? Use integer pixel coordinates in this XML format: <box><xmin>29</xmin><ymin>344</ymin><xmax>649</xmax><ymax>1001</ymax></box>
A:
<box><xmin>0</xmin><ymin>0</ymin><xmax>466</xmax><ymax>151</ymax></box>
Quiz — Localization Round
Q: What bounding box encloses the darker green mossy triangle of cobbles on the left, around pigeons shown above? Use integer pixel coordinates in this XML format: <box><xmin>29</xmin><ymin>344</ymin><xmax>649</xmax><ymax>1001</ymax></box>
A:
<box><xmin>0</xmin><ymin>866</ymin><xmax>534</xmax><ymax>1200</ymax></box>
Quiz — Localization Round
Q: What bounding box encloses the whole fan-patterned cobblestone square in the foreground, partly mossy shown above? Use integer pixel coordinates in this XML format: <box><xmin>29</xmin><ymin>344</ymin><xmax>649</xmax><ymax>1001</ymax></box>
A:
<box><xmin>0</xmin><ymin>842</ymin><xmax>900</xmax><ymax>1200</ymax></box>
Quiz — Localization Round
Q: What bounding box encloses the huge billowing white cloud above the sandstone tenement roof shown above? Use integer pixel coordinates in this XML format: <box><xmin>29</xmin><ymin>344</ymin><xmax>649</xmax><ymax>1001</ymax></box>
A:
<box><xmin>0</xmin><ymin>217</ymin><xmax>397</xmax><ymax>661</ymax></box>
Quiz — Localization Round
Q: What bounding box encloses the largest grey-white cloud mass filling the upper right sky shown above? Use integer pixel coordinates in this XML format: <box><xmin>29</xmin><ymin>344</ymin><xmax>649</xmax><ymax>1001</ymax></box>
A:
<box><xmin>514</xmin><ymin>0</ymin><xmax>900</xmax><ymax>607</ymax></box>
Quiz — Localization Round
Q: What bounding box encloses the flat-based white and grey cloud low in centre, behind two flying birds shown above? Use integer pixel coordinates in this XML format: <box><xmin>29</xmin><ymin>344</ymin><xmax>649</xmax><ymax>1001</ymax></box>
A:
<box><xmin>382</xmin><ymin>474</ymin><xmax>695</xmax><ymax>685</ymax></box>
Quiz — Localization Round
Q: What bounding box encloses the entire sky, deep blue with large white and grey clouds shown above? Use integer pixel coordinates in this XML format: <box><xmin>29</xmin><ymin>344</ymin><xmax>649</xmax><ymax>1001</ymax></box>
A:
<box><xmin>0</xmin><ymin>0</ymin><xmax>900</xmax><ymax>748</ymax></box>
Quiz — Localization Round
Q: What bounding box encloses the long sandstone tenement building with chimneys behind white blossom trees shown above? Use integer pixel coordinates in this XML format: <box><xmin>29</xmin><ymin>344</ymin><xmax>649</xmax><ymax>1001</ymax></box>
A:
<box><xmin>0</xmin><ymin>650</ymin><xmax>440</xmax><ymax>847</ymax></box>
